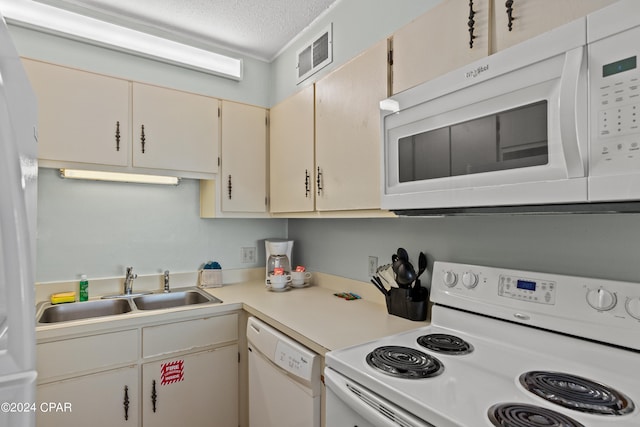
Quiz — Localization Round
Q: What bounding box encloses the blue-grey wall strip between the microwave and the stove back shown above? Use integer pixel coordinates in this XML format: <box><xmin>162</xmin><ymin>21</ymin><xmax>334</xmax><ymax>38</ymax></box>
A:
<box><xmin>289</xmin><ymin>214</ymin><xmax>640</xmax><ymax>283</ymax></box>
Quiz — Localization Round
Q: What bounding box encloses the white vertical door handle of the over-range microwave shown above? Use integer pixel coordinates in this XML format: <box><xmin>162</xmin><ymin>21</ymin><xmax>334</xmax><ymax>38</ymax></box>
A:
<box><xmin>559</xmin><ymin>46</ymin><xmax>587</xmax><ymax>178</ymax></box>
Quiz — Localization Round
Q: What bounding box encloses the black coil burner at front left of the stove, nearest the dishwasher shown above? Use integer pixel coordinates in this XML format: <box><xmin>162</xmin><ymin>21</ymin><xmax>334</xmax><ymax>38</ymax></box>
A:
<box><xmin>367</xmin><ymin>346</ymin><xmax>444</xmax><ymax>379</ymax></box>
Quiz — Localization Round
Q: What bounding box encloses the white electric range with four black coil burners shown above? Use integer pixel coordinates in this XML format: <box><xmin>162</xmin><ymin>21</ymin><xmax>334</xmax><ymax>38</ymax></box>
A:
<box><xmin>325</xmin><ymin>262</ymin><xmax>640</xmax><ymax>427</ymax></box>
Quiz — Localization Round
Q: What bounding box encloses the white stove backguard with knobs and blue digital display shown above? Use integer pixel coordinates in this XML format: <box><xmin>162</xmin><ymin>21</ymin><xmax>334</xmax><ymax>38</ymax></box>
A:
<box><xmin>430</xmin><ymin>261</ymin><xmax>640</xmax><ymax>350</ymax></box>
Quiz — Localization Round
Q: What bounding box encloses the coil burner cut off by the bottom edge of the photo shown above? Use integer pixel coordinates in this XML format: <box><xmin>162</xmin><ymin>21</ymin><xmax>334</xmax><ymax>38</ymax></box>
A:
<box><xmin>488</xmin><ymin>403</ymin><xmax>585</xmax><ymax>427</ymax></box>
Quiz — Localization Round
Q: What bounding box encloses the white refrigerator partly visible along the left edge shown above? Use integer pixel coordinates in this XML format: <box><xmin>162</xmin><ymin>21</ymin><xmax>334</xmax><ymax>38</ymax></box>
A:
<box><xmin>0</xmin><ymin>6</ymin><xmax>38</xmax><ymax>427</ymax></box>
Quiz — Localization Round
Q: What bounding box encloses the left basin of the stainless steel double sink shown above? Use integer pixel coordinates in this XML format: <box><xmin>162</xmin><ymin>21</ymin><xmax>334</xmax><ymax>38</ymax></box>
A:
<box><xmin>38</xmin><ymin>299</ymin><xmax>134</xmax><ymax>323</ymax></box>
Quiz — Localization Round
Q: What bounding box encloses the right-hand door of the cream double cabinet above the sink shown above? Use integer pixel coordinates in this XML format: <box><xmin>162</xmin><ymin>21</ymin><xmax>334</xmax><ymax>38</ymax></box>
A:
<box><xmin>133</xmin><ymin>83</ymin><xmax>219</xmax><ymax>174</ymax></box>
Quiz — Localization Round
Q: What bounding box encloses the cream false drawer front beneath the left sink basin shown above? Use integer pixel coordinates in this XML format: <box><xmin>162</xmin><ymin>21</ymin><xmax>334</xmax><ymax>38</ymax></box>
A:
<box><xmin>36</xmin><ymin>329</ymin><xmax>138</xmax><ymax>381</ymax></box>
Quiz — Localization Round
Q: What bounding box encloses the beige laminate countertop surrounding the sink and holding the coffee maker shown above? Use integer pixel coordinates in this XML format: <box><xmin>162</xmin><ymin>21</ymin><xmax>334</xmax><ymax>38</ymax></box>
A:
<box><xmin>36</xmin><ymin>269</ymin><xmax>428</xmax><ymax>356</ymax></box>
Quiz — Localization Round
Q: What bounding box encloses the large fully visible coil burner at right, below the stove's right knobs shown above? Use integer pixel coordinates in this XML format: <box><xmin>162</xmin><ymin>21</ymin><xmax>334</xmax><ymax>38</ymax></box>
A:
<box><xmin>520</xmin><ymin>371</ymin><xmax>634</xmax><ymax>415</ymax></box>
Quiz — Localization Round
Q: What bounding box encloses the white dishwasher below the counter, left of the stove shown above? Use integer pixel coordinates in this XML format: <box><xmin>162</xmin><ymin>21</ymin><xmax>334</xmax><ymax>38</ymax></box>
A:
<box><xmin>247</xmin><ymin>317</ymin><xmax>322</xmax><ymax>427</ymax></box>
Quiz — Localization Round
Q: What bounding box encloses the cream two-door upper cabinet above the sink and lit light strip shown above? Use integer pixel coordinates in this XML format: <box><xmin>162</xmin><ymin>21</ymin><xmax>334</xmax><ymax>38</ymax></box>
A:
<box><xmin>23</xmin><ymin>59</ymin><xmax>219</xmax><ymax>178</ymax></box>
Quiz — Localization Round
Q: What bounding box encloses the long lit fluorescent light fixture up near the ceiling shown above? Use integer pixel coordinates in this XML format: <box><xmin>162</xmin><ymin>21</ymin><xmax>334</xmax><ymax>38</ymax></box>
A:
<box><xmin>1</xmin><ymin>0</ymin><xmax>242</xmax><ymax>80</ymax></box>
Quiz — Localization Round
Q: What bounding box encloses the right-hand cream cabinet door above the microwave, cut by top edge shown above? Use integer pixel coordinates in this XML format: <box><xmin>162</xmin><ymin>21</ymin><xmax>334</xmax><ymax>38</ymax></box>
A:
<box><xmin>493</xmin><ymin>0</ymin><xmax>615</xmax><ymax>52</ymax></box>
